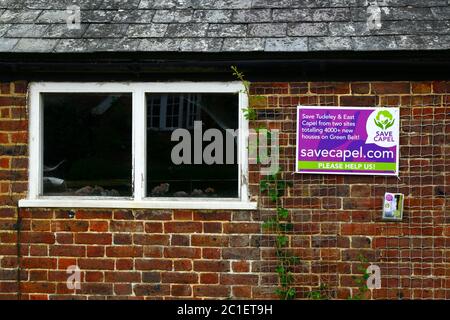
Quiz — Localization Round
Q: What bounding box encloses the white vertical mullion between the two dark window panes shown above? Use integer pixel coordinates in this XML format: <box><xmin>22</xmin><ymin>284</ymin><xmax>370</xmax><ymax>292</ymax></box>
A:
<box><xmin>133</xmin><ymin>88</ymin><xmax>147</xmax><ymax>201</ymax></box>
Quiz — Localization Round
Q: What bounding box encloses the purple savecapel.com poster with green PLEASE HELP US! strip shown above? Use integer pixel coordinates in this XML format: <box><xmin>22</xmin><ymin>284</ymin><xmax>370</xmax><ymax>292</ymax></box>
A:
<box><xmin>296</xmin><ymin>106</ymin><xmax>400</xmax><ymax>176</ymax></box>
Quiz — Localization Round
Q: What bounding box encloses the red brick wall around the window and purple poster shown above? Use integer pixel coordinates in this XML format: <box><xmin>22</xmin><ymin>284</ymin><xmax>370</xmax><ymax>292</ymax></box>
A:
<box><xmin>0</xmin><ymin>82</ymin><xmax>450</xmax><ymax>299</ymax></box>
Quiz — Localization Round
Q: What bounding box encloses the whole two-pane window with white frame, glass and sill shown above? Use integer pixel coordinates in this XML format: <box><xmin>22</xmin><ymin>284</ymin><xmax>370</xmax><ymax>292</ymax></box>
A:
<box><xmin>19</xmin><ymin>82</ymin><xmax>256</xmax><ymax>209</ymax></box>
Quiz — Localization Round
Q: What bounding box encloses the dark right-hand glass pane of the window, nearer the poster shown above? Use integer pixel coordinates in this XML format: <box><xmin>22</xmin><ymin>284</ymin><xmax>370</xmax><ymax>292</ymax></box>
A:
<box><xmin>146</xmin><ymin>93</ymin><xmax>239</xmax><ymax>198</ymax></box>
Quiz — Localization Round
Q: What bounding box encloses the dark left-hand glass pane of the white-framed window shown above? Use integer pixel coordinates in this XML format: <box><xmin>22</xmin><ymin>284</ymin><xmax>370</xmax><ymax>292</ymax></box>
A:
<box><xmin>41</xmin><ymin>93</ymin><xmax>132</xmax><ymax>197</ymax></box>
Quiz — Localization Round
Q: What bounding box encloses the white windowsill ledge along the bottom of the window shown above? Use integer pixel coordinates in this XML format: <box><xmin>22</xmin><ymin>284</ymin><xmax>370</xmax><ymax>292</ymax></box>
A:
<box><xmin>19</xmin><ymin>198</ymin><xmax>257</xmax><ymax>210</ymax></box>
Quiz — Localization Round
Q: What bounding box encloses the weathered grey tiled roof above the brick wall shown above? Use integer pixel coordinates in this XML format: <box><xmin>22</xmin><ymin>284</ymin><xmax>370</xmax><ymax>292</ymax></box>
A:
<box><xmin>0</xmin><ymin>0</ymin><xmax>450</xmax><ymax>52</ymax></box>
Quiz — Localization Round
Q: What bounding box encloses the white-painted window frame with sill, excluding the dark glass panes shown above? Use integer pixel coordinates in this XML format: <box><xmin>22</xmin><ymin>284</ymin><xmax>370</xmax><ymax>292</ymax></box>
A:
<box><xmin>19</xmin><ymin>82</ymin><xmax>257</xmax><ymax>210</ymax></box>
